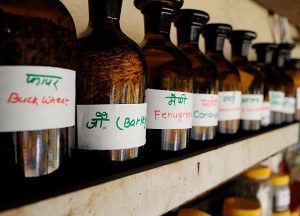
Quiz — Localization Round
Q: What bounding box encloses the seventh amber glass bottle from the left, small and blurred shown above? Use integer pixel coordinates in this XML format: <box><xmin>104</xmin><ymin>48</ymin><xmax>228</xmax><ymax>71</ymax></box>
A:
<box><xmin>252</xmin><ymin>43</ymin><xmax>285</xmax><ymax>125</ymax></box>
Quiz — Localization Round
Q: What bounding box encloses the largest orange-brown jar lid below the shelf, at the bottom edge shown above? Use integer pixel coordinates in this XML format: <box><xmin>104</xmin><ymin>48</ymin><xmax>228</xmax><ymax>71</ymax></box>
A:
<box><xmin>223</xmin><ymin>197</ymin><xmax>261</xmax><ymax>216</ymax></box>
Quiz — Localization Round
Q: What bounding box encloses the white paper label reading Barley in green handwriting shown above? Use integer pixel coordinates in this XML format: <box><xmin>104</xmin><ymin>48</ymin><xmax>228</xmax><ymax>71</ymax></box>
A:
<box><xmin>77</xmin><ymin>103</ymin><xmax>147</xmax><ymax>150</ymax></box>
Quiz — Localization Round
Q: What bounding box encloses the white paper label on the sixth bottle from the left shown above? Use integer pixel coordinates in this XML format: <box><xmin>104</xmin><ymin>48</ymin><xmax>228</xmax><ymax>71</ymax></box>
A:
<box><xmin>241</xmin><ymin>94</ymin><xmax>263</xmax><ymax>121</ymax></box>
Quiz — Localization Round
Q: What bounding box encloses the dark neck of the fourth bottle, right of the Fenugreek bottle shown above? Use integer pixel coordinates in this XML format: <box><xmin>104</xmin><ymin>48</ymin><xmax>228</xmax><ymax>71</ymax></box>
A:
<box><xmin>177</xmin><ymin>26</ymin><xmax>201</xmax><ymax>49</ymax></box>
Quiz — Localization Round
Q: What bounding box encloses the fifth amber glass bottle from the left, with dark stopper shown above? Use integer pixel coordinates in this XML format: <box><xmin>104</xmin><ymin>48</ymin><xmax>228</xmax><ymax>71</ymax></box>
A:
<box><xmin>203</xmin><ymin>24</ymin><xmax>241</xmax><ymax>134</ymax></box>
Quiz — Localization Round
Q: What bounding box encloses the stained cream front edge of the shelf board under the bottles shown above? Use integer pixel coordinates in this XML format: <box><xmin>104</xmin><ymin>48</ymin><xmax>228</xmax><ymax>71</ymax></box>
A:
<box><xmin>0</xmin><ymin>123</ymin><xmax>299</xmax><ymax>216</ymax></box>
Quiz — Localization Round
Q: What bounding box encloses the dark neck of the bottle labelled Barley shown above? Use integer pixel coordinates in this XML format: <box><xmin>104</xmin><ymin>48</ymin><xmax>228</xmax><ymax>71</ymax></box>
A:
<box><xmin>89</xmin><ymin>0</ymin><xmax>123</xmax><ymax>28</ymax></box>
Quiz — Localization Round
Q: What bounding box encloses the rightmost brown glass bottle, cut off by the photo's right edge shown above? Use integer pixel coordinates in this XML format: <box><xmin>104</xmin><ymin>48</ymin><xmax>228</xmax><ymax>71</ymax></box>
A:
<box><xmin>285</xmin><ymin>59</ymin><xmax>300</xmax><ymax>121</ymax></box>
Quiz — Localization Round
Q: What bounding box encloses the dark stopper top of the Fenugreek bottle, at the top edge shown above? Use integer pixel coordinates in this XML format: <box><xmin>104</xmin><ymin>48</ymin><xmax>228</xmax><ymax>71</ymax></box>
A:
<box><xmin>134</xmin><ymin>0</ymin><xmax>183</xmax><ymax>12</ymax></box>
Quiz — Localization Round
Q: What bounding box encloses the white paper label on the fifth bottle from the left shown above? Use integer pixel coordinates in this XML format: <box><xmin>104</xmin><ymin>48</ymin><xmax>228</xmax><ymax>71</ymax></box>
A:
<box><xmin>218</xmin><ymin>91</ymin><xmax>241</xmax><ymax>121</ymax></box>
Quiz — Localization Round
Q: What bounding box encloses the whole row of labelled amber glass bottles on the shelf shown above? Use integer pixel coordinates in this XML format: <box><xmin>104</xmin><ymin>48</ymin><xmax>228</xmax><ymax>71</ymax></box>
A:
<box><xmin>0</xmin><ymin>0</ymin><xmax>299</xmax><ymax>177</ymax></box>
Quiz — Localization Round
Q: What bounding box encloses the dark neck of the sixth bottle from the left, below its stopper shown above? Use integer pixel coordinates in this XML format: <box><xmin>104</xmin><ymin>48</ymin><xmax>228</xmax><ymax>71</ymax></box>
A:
<box><xmin>231</xmin><ymin>40</ymin><xmax>251</xmax><ymax>61</ymax></box>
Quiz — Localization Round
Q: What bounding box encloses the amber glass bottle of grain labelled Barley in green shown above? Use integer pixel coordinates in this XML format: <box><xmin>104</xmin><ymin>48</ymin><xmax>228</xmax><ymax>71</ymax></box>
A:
<box><xmin>76</xmin><ymin>0</ymin><xmax>146</xmax><ymax>162</ymax></box>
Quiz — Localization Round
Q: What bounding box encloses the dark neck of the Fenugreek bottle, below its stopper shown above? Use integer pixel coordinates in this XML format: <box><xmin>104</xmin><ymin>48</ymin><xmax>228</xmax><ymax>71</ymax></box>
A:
<box><xmin>144</xmin><ymin>9</ymin><xmax>174</xmax><ymax>39</ymax></box>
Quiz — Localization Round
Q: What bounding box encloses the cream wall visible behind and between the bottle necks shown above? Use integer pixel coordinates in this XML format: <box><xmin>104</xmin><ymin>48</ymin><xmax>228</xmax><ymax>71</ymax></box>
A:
<box><xmin>61</xmin><ymin>0</ymin><xmax>300</xmax><ymax>60</ymax></box>
